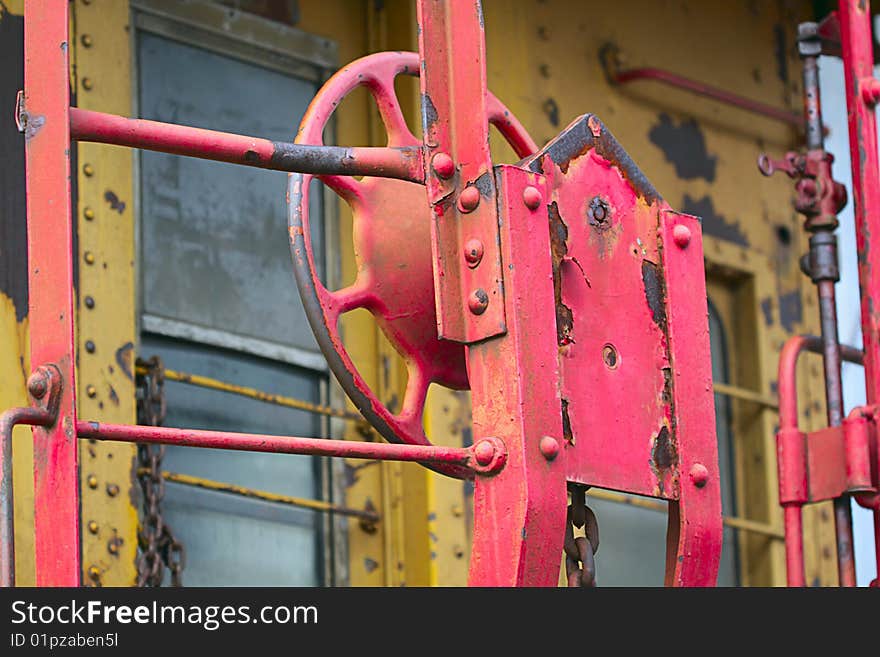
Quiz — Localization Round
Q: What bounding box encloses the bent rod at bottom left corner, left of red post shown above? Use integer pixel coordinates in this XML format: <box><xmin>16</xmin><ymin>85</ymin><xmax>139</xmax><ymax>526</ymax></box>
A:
<box><xmin>0</xmin><ymin>406</ymin><xmax>55</xmax><ymax>587</ymax></box>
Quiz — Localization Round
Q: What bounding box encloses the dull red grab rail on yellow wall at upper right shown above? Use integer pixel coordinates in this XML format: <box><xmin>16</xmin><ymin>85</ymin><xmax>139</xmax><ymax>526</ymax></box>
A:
<box><xmin>600</xmin><ymin>46</ymin><xmax>804</xmax><ymax>129</ymax></box>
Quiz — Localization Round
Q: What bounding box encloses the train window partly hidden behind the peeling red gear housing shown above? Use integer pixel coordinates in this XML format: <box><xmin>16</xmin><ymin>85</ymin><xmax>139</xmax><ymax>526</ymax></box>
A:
<box><xmin>587</xmin><ymin>300</ymin><xmax>740</xmax><ymax>586</ymax></box>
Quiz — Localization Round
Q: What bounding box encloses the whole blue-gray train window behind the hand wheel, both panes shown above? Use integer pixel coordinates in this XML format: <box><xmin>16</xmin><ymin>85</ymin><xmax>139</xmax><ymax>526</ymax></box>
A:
<box><xmin>136</xmin><ymin>9</ymin><xmax>336</xmax><ymax>586</ymax></box>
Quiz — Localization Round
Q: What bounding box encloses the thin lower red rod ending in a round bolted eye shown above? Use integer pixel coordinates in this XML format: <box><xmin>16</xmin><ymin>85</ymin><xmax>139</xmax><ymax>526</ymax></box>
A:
<box><xmin>76</xmin><ymin>421</ymin><xmax>504</xmax><ymax>472</ymax></box>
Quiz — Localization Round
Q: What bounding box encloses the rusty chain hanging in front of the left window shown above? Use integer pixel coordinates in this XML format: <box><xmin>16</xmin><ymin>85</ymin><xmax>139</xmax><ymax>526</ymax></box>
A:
<box><xmin>137</xmin><ymin>356</ymin><xmax>186</xmax><ymax>587</ymax></box>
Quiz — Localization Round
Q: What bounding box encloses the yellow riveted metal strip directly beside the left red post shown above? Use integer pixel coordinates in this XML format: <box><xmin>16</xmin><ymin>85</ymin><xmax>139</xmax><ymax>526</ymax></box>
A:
<box><xmin>73</xmin><ymin>0</ymin><xmax>139</xmax><ymax>586</ymax></box>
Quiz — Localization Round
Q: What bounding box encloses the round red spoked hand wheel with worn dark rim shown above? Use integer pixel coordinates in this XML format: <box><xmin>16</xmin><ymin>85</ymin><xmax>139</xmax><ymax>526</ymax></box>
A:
<box><xmin>288</xmin><ymin>52</ymin><xmax>537</xmax><ymax>478</ymax></box>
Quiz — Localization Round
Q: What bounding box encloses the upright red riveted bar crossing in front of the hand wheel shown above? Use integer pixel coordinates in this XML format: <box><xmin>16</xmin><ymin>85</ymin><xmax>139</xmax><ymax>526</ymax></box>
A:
<box><xmin>417</xmin><ymin>0</ymin><xmax>507</xmax><ymax>344</ymax></box>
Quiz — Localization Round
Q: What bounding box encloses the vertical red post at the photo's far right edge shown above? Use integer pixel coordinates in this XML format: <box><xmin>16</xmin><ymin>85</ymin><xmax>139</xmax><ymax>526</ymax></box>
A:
<box><xmin>839</xmin><ymin>0</ymin><xmax>880</xmax><ymax>579</ymax></box>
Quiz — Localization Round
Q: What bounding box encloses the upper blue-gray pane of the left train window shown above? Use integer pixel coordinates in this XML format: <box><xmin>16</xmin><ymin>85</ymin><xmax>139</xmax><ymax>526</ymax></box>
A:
<box><xmin>138</xmin><ymin>33</ymin><xmax>323</xmax><ymax>351</ymax></box>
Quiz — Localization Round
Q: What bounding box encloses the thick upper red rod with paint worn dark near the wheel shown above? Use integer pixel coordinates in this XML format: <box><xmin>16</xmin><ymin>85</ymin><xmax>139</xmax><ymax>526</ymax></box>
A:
<box><xmin>70</xmin><ymin>107</ymin><xmax>425</xmax><ymax>183</ymax></box>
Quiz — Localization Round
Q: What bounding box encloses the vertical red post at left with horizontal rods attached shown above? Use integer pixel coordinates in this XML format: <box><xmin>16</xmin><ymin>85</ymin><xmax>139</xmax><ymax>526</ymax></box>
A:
<box><xmin>21</xmin><ymin>0</ymin><xmax>80</xmax><ymax>586</ymax></box>
